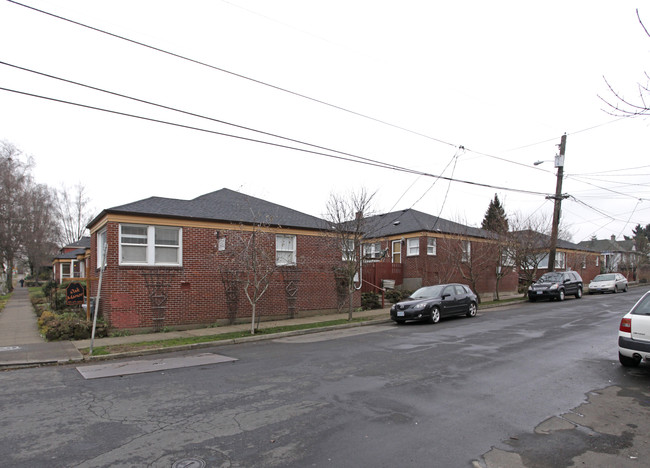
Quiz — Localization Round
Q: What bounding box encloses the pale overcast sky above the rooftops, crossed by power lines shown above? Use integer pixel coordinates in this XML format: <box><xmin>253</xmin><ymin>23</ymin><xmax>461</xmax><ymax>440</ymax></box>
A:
<box><xmin>0</xmin><ymin>0</ymin><xmax>650</xmax><ymax>242</ymax></box>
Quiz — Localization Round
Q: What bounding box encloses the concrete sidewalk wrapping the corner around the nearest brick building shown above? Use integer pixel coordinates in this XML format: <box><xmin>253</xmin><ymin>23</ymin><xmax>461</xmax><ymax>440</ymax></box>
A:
<box><xmin>0</xmin><ymin>287</ymin><xmax>389</xmax><ymax>368</ymax></box>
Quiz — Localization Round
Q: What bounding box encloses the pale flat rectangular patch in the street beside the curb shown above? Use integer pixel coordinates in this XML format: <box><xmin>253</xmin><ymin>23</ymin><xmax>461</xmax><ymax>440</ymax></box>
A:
<box><xmin>77</xmin><ymin>353</ymin><xmax>237</xmax><ymax>380</ymax></box>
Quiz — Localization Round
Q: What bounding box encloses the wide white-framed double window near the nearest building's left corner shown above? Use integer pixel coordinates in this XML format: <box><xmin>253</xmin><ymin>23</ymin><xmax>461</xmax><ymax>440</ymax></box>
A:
<box><xmin>120</xmin><ymin>224</ymin><xmax>182</xmax><ymax>266</ymax></box>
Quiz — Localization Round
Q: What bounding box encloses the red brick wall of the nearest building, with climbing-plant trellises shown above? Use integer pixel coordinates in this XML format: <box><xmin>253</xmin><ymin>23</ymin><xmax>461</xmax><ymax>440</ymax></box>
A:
<box><xmin>89</xmin><ymin>222</ymin><xmax>360</xmax><ymax>329</ymax></box>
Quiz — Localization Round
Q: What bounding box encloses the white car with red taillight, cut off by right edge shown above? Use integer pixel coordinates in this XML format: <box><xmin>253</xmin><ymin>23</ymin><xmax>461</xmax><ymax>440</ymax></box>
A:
<box><xmin>618</xmin><ymin>291</ymin><xmax>650</xmax><ymax>367</ymax></box>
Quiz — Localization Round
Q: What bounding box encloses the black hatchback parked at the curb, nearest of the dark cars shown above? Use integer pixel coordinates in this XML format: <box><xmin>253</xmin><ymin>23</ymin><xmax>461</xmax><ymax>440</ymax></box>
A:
<box><xmin>390</xmin><ymin>284</ymin><xmax>478</xmax><ymax>324</ymax></box>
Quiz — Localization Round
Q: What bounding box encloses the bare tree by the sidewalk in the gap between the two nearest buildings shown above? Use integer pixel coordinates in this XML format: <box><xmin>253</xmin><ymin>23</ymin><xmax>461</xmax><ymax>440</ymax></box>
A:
<box><xmin>325</xmin><ymin>189</ymin><xmax>374</xmax><ymax>320</ymax></box>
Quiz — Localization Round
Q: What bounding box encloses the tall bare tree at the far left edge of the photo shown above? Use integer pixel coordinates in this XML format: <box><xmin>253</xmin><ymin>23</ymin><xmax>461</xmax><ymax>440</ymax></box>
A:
<box><xmin>0</xmin><ymin>141</ymin><xmax>32</xmax><ymax>291</ymax></box>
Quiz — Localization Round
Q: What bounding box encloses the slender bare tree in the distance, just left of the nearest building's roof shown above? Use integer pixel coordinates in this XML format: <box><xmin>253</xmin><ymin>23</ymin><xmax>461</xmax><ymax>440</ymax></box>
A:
<box><xmin>57</xmin><ymin>183</ymin><xmax>93</xmax><ymax>245</ymax></box>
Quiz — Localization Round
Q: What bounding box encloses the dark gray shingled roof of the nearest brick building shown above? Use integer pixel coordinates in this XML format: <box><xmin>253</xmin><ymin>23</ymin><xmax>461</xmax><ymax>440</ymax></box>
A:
<box><xmin>88</xmin><ymin>188</ymin><xmax>327</xmax><ymax>230</ymax></box>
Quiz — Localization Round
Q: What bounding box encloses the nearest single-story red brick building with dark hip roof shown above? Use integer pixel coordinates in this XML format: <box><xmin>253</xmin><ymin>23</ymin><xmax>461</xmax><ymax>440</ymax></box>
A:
<box><xmin>88</xmin><ymin>189</ymin><xmax>360</xmax><ymax>329</ymax></box>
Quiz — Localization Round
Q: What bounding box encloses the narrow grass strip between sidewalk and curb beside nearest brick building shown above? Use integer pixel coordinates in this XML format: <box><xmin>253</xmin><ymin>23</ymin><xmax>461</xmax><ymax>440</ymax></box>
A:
<box><xmin>79</xmin><ymin>317</ymin><xmax>382</xmax><ymax>356</ymax></box>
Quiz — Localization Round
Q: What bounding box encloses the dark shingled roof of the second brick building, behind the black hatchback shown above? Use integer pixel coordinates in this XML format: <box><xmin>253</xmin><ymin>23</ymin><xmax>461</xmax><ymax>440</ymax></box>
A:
<box><xmin>364</xmin><ymin>209</ymin><xmax>492</xmax><ymax>239</ymax></box>
